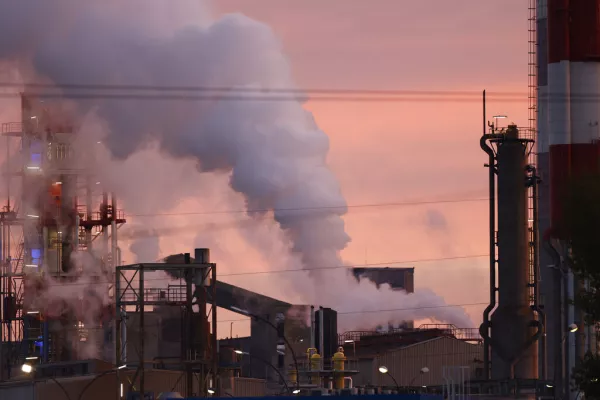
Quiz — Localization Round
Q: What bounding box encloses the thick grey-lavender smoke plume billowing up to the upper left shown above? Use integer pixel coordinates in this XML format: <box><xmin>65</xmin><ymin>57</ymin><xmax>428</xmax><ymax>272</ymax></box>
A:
<box><xmin>0</xmin><ymin>0</ymin><xmax>471</xmax><ymax>326</ymax></box>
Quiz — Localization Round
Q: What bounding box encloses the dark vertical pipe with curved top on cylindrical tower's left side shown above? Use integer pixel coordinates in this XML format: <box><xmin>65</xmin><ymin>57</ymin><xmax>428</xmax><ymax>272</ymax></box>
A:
<box><xmin>479</xmin><ymin>132</ymin><xmax>496</xmax><ymax>379</ymax></box>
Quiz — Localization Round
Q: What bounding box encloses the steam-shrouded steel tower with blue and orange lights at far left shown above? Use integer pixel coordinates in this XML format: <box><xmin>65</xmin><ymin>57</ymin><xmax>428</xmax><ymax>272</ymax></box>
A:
<box><xmin>0</xmin><ymin>94</ymin><xmax>126</xmax><ymax>379</ymax></box>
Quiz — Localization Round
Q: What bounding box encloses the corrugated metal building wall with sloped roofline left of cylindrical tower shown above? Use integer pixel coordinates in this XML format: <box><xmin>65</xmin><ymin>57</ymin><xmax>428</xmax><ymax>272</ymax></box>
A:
<box><xmin>371</xmin><ymin>337</ymin><xmax>483</xmax><ymax>386</ymax></box>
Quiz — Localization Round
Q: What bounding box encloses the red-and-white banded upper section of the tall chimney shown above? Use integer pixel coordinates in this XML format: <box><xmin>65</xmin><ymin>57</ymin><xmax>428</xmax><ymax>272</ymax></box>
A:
<box><xmin>538</xmin><ymin>0</ymin><xmax>600</xmax><ymax>237</ymax></box>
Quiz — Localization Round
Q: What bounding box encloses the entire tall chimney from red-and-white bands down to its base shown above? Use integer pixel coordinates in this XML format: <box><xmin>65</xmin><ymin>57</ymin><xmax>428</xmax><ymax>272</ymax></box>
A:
<box><xmin>536</xmin><ymin>0</ymin><xmax>600</xmax><ymax>398</ymax></box>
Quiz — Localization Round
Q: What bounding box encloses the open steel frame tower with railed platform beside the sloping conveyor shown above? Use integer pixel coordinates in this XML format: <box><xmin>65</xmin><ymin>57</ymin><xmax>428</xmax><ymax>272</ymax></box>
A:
<box><xmin>115</xmin><ymin>249</ymin><xmax>219</xmax><ymax>397</ymax></box>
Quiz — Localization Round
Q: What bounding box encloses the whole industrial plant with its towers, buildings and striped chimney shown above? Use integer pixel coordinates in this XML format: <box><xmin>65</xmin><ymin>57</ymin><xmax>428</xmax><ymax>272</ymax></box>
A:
<box><xmin>0</xmin><ymin>0</ymin><xmax>600</xmax><ymax>400</ymax></box>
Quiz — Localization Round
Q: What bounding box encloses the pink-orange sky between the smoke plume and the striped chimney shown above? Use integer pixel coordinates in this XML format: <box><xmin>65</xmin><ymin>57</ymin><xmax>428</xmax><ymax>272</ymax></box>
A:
<box><xmin>204</xmin><ymin>0</ymin><xmax>528</xmax><ymax>334</ymax></box>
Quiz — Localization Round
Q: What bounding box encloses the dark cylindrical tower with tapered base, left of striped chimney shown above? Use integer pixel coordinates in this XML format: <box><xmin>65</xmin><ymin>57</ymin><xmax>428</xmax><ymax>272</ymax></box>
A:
<box><xmin>491</xmin><ymin>126</ymin><xmax>537</xmax><ymax>379</ymax></box>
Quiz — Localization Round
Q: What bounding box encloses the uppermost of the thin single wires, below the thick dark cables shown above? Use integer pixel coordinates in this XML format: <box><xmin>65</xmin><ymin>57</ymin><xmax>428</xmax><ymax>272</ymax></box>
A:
<box><xmin>127</xmin><ymin>197</ymin><xmax>489</xmax><ymax>217</ymax></box>
